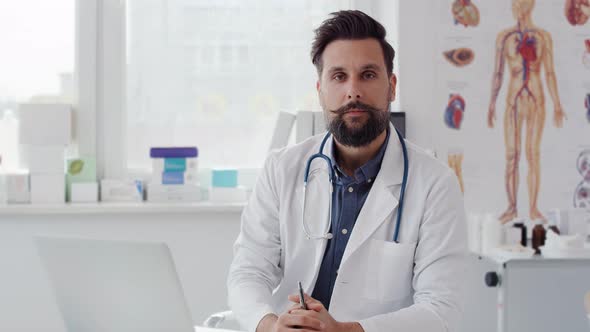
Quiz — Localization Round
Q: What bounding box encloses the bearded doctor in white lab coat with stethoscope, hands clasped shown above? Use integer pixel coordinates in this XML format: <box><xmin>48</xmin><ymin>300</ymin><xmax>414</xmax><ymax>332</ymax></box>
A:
<box><xmin>228</xmin><ymin>11</ymin><xmax>467</xmax><ymax>332</ymax></box>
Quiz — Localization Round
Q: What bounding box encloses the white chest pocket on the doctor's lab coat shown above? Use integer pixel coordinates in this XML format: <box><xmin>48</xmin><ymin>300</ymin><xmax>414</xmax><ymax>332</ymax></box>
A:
<box><xmin>364</xmin><ymin>239</ymin><xmax>416</xmax><ymax>302</ymax></box>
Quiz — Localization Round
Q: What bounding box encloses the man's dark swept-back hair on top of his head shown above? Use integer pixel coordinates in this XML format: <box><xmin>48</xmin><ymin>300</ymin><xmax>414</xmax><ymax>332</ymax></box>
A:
<box><xmin>311</xmin><ymin>10</ymin><xmax>395</xmax><ymax>75</ymax></box>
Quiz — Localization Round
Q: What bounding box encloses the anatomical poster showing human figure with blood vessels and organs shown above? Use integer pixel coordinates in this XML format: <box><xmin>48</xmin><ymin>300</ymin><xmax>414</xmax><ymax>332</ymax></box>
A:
<box><xmin>431</xmin><ymin>0</ymin><xmax>590</xmax><ymax>223</ymax></box>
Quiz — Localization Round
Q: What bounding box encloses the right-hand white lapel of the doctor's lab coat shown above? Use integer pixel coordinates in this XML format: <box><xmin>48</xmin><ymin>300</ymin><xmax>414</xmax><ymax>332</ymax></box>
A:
<box><xmin>341</xmin><ymin>125</ymin><xmax>404</xmax><ymax>264</ymax></box>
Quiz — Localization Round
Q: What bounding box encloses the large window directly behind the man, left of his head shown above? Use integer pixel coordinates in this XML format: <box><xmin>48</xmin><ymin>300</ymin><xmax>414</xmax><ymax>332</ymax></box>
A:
<box><xmin>125</xmin><ymin>0</ymin><xmax>351</xmax><ymax>169</ymax></box>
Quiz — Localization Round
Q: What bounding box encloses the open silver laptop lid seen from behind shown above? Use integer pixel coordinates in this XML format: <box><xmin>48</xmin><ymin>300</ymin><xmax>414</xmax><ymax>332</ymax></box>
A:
<box><xmin>35</xmin><ymin>237</ymin><xmax>195</xmax><ymax>332</ymax></box>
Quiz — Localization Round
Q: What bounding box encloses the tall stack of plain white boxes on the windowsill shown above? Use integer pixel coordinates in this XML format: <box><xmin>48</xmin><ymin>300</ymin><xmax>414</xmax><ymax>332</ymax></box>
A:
<box><xmin>19</xmin><ymin>104</ymin><xmax>71</xmax><ymax>204</ymax></box>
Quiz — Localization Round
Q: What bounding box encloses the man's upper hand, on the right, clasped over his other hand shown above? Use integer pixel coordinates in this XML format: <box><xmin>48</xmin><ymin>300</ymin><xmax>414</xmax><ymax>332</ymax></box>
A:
<box><xmin>288</xmin><ymin>294</ymin><xmax>364</xmax><ymax>332</ymax></box>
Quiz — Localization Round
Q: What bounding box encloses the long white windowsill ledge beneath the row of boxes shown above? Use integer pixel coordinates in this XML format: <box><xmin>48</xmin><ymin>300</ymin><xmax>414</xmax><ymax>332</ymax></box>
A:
<box><xmin>0</xmin><ymin>202</ymin><xmax>246</xmax><ymax>217</ymax></box>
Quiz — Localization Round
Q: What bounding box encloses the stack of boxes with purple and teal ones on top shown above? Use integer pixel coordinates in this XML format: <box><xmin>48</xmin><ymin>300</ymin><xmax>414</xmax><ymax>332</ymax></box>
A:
<box><xmin>147</xmin><ymin>147</ymin><xmax>201</xmax><ymax>203</ymax></box>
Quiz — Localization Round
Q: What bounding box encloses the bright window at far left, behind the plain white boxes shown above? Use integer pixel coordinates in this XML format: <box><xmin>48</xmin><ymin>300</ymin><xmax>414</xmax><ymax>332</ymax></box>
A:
<box><xmin>0</xmin><ymin>0</ymin><xmax>75</xmax><ymax>169</ymax></box>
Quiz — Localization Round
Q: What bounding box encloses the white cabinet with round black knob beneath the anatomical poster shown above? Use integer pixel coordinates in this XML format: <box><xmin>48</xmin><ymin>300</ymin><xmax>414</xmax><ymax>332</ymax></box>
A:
<box><xmin>461</xmin><ymin>255</ymin><xmax>590</xmax><ymax>332</ymax></box>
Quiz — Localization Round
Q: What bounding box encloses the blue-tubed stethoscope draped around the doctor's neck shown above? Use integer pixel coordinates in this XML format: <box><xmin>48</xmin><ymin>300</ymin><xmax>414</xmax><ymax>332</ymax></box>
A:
<box><xmin>301</xmin><ymin>129</ymin><xmax>408</xmax><ymax>243</ymax></box>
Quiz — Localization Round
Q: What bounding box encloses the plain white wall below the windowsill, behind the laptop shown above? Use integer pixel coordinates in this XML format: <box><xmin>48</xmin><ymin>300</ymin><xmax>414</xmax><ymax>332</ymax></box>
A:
<box><xmin>0</xmin><ymin>207</ymin><xmax>241</xmax><ymax>332</ymax></box>
